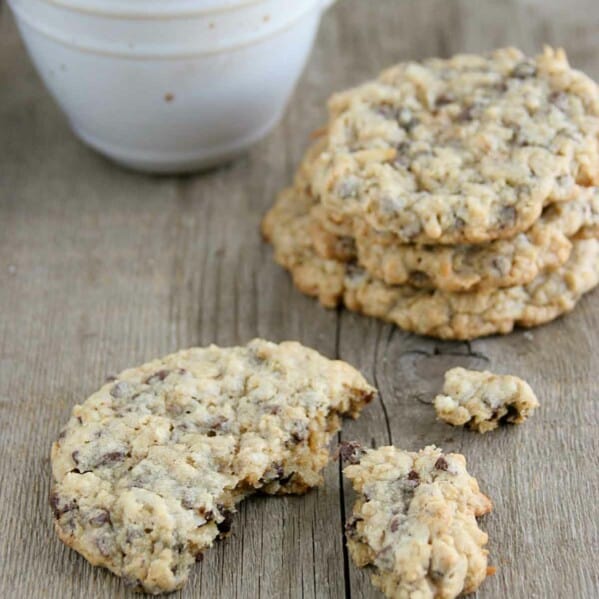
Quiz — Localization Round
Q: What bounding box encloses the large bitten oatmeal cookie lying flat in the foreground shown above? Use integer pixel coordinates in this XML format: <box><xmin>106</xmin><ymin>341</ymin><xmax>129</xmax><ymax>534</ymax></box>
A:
<box><xmin>50</xmin><ymin>339</ymin><xmax>374</xmax><ymax>593</ymax></box>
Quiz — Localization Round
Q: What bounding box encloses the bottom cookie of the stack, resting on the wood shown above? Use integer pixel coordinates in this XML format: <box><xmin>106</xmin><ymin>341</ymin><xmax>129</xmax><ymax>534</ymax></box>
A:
<box><xmin>262</xmin><ymin>189</ymin><xmax>599</xmax><ymax>339</ymax></box>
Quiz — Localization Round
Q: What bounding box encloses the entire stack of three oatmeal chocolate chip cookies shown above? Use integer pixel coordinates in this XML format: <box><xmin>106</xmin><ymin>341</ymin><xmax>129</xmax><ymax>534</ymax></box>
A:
<box><xmin>262</xmin><ymin>48</ymin><xmax>599</xmax><ymax>339</ymax></box>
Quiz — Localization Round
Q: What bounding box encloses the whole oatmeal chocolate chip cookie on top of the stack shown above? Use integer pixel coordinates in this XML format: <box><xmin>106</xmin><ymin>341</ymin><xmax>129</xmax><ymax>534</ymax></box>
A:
<box><xmin>312</xmin><ymin>48</ymin><xmax>599</xmax><ymax>244</ymax></box>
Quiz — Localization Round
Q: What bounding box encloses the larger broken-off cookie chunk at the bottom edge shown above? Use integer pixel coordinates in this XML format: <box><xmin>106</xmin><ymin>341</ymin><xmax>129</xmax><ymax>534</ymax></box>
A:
<box><xmin>343</xmin><ymin>446</ymin><xmax>492</xmax><ymax>599</ymax></box>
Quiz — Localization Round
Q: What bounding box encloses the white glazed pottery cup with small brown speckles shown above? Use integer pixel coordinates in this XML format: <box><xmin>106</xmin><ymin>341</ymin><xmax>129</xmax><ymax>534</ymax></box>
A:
<box><xmin>9</xmin><ymin>0</ymin><xmax>333</xmax><ymax>172</ymax></box>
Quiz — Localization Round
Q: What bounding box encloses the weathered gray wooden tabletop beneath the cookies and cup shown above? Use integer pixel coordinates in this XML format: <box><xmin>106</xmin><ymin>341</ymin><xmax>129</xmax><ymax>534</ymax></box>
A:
<box><xmin>0</xmin><ymin>0</ymin><xmax>599</xmax><ymax>599</ymax></box>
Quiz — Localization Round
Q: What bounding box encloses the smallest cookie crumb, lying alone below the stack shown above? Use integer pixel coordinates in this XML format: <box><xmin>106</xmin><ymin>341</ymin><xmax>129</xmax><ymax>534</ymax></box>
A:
<box><xmin>434</xmin><ymin>368</ymin><xmax>539</xmax><ymax>433</ymax></box>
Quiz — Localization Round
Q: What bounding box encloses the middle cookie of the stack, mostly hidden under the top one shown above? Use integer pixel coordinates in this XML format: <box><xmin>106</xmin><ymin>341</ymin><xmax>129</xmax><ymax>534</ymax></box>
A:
<box><xmin>311</xmin><ymin>187</ymin><xmax>599</xmax><ymax>291</ymax></box>
